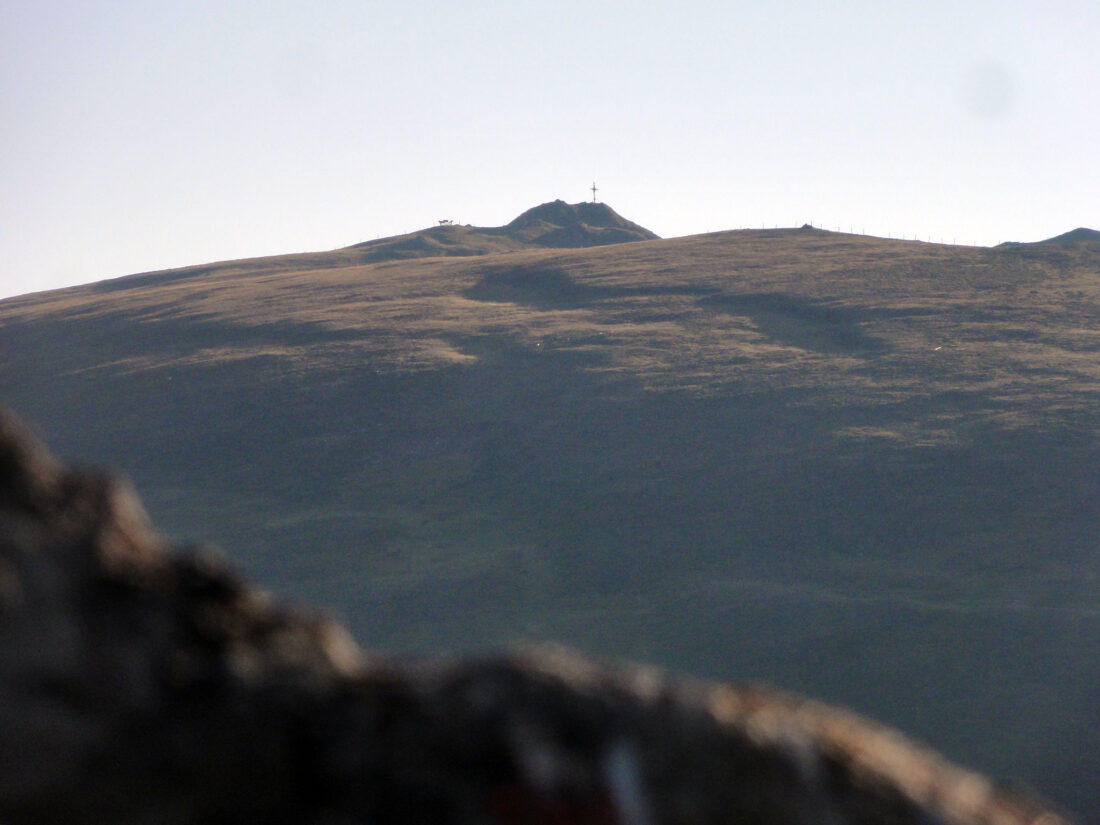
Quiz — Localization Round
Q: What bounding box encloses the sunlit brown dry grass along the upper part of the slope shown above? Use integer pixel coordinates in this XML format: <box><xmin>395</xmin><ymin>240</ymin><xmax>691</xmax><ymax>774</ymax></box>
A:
<box><xmin>0</xmin><ymin>230</ymin><xmax>1100</xmax><ymax>446</ymax></box>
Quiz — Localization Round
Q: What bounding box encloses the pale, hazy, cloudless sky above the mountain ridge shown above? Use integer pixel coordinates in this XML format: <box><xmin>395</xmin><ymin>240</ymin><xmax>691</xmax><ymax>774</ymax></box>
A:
<box><xmin>0</xmin><ymin>0</ymin><xmax>1100</xmax><ymax>296</ymax></box>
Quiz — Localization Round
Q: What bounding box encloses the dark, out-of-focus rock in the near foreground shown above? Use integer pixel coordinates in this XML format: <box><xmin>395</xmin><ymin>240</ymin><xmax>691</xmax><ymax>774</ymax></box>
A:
<box><xmin>0</xmin><ymin>416</ymin><xmax>1064</xmax><ymax>825</ymax></box>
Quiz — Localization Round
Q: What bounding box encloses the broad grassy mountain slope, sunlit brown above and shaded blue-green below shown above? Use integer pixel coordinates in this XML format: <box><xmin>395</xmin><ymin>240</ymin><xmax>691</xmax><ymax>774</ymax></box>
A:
<box><xmin>0</xmin><ymin>224</ymin><xmax>1100</xmax><ymax>821</ymax></box>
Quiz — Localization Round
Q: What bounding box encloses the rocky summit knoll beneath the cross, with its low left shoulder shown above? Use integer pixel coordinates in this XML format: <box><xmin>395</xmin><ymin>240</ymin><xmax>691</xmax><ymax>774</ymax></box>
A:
<box><xmin>349</xmin><ymin>200</ymin><xmax>659</xmax><ymax>263</ymax></box>
